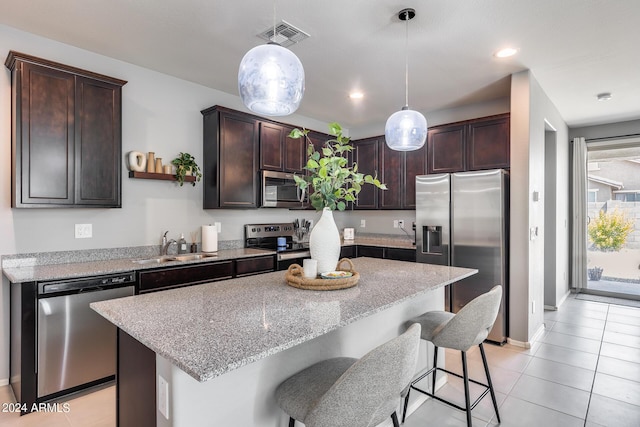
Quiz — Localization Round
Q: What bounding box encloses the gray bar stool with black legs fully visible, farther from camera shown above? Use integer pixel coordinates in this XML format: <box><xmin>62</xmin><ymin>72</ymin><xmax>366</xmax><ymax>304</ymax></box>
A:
<box><xmin>402</xmin><ymin>286</ymin><xmax>502</xmax><ymax>427</ymax></box>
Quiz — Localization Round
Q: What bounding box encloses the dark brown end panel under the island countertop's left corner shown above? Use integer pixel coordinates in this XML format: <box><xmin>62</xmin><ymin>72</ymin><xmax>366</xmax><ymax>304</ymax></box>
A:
<box><xmin>116</xmin><ymin>329</ymin><xmax>156</xmax><ymax>427</ymax></box>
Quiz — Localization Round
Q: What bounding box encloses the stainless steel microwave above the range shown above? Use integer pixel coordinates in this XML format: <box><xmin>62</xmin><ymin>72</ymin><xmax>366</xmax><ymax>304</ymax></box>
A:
<box><xmin>261</xmin><ymin>171</ymin><xmax>308</xmax><ymax>209</ymax></box>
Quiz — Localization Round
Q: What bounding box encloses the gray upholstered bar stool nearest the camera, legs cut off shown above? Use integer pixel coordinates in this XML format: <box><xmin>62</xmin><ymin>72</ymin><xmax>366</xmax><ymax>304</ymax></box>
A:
<box><xmin>276</xmin><ymin>324</ymin><xmax>420</xmax><ymax>427</ymax></box>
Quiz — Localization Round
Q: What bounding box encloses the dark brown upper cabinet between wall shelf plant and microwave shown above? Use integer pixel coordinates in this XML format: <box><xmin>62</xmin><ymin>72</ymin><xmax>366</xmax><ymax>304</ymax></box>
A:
<box><xmin>202</xmin><ymin>106</ymin><xmax>260</xmax><ymax>209</ymax></box>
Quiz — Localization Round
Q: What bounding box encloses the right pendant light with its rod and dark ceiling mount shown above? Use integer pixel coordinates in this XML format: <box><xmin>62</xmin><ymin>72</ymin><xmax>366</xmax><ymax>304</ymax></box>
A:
<box><xmin>384</xmin><ymin>9</ymin><xmax>427</xmax><ymax>151</ymax></box>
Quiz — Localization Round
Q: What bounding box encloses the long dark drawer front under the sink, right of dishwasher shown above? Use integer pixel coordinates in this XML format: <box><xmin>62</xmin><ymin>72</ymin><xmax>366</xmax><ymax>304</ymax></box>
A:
<box><xmin>139</xmin><ymin>261</ymin><xmax>233</xmax><ymax>294</ymax></box>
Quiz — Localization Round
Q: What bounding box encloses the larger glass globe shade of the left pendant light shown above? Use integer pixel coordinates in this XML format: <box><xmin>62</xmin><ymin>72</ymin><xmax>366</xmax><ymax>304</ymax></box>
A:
<box><xmin>238</xmin><ymin>43</ymin><xmax>304</xmax><ymax>116</ymax></box>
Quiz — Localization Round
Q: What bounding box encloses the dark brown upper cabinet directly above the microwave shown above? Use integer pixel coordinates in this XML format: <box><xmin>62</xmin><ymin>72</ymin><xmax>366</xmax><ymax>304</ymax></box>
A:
<box><xmin>260</xmin><ymin>122</ymin><xmax>306</xmax><ymax>173</ymax></box>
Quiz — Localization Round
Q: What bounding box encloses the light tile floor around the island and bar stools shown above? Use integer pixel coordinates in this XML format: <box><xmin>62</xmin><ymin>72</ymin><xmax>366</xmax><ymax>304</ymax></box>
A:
<box><xmin>0</xmin><ymin>296</ymin><xmax>640</xmax><ymax>427</ymax></box>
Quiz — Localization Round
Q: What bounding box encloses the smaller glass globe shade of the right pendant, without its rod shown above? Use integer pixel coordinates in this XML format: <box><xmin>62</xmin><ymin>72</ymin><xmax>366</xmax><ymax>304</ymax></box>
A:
<box><xmin>384</xmin><ymin>107</ymin><xmax>427</xmax><ymax>151</ymax></box>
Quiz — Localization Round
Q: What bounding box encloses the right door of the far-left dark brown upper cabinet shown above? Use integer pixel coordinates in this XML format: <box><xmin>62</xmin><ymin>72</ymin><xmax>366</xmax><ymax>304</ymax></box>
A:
<box><xmin>75</xmin><ymin>77</ymin><xmax>122</xmax><ymax>207</ymax></box>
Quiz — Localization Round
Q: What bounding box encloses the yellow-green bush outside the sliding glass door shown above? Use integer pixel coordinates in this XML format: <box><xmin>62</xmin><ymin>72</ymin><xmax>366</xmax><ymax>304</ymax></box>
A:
<box><xmin>587</xmin><ymin>209</ymin><xmax>633</xmax><ymax>252</ymax></box>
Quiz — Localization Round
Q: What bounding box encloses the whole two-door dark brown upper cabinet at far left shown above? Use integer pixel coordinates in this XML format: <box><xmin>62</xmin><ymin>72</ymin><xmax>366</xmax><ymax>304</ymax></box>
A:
<box><xmin>5</xmin><ymin>51</ymin><xmax>126</xmax><ymax>208</ymax></box>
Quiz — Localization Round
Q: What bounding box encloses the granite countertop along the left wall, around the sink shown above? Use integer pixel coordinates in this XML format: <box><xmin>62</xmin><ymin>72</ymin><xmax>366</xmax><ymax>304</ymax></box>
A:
<box><xmin>2</xmin><ymin>248</ymin><xmax>276</xmax><ymax>283</ymax></box>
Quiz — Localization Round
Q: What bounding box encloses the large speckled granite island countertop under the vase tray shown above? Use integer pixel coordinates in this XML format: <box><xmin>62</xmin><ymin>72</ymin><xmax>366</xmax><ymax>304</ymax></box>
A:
<box><xmin>91</xmin><ymin>258</ymin><xmax>477</xmax><ymax>382</ymax></box>
